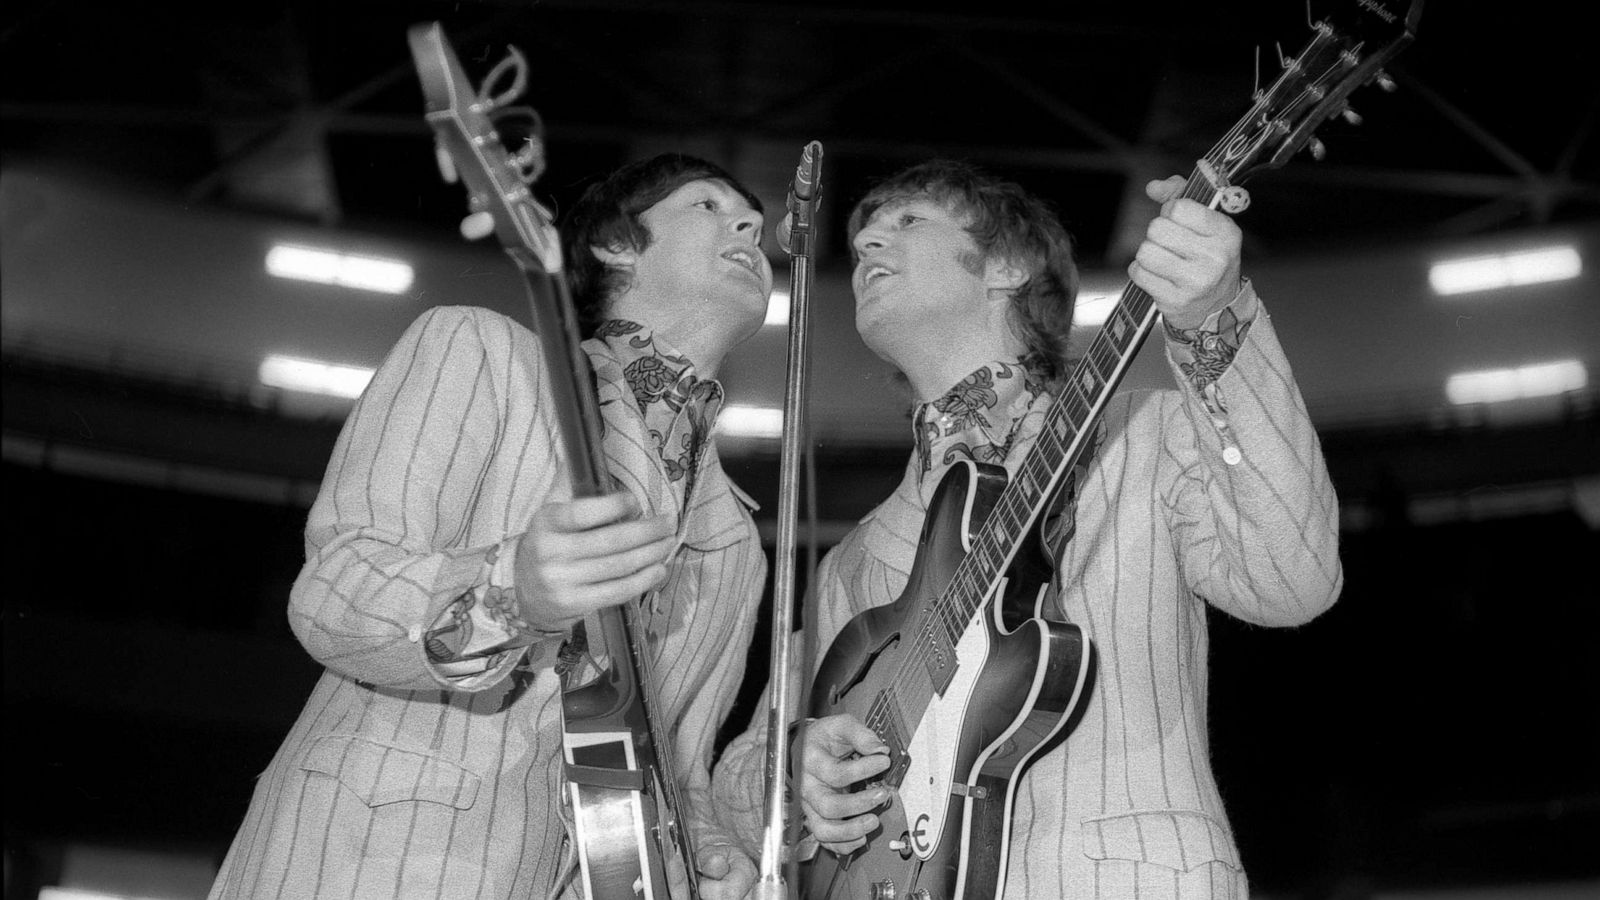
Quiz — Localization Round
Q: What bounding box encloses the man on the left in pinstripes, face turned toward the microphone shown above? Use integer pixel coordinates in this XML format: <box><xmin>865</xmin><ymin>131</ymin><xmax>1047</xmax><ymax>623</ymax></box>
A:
<box><xmin>211</xmin><ymin>155</ymin><xmax>771</xmax><ymax>900</ymax></box>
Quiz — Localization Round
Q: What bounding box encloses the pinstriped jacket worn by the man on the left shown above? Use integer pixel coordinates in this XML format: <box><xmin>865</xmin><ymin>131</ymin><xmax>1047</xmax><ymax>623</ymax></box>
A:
<box><xmin>211</xmin><ymin>307</ymin><xmax>766</xmax><ymax>900</ymax></box>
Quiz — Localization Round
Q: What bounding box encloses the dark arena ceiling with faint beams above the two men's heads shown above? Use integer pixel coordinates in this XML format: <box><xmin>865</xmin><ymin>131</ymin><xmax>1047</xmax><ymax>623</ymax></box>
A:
<box><xmin>0</xmin><ymin>0</ymin><xmax>1600</xmax><ymax>264</ymax></box>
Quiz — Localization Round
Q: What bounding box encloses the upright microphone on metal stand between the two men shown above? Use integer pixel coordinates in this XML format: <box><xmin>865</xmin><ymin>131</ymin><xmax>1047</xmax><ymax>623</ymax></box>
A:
<box><xmin>757</xmin><ymin>141</ymin><xmax>822</xmax><ymax>900</ymax></box>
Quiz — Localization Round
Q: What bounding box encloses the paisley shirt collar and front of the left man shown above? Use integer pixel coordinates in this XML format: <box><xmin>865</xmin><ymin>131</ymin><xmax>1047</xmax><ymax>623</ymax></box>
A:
<box><xmin>595</xmin><ymin>319</ymin><xmax>723</xmax><ymax>483</ymax></box>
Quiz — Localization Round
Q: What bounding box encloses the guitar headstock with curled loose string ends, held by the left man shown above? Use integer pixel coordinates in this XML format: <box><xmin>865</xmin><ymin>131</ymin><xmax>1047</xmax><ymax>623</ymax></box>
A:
<box><xmin>406</xmin><ymin>22</ymin><xmax>562</xmax><ymax>274</ymax></box>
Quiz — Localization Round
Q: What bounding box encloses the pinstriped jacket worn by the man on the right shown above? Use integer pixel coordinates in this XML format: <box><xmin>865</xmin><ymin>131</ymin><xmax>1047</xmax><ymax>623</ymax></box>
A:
<box><xmin>715</xmin><ymin>291</ymin><xmax>1342</xmax><ymax>900</ymax></box>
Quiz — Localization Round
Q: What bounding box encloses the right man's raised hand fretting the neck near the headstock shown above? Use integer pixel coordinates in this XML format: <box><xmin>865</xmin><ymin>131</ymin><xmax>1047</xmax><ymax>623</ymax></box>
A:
<box><xmin>1128</xmin><ymin>175</ymin><xmax>1242</xmax><ymax>331</ymax></box>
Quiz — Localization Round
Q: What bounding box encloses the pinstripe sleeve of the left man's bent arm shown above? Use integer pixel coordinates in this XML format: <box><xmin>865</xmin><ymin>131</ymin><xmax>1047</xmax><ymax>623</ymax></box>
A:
<box><xmin>290</xmin><ymin>307</ymin><xmax>555</xmax><ymax>690</ymax></box>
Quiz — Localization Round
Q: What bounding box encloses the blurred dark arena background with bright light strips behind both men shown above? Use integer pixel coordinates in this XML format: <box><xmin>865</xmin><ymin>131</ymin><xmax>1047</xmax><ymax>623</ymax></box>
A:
<box><xmin>0</xmin><ymin>0</ymin><xmax>1600</xmax><ymax>900</ymax></box>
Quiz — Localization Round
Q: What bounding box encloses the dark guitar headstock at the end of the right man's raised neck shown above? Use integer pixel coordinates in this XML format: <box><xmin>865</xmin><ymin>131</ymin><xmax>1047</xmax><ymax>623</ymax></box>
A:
<box><xmin>1206</xmin><ymin>0</ymin><xmax>1422</xmax><ymax>184</ymax></box>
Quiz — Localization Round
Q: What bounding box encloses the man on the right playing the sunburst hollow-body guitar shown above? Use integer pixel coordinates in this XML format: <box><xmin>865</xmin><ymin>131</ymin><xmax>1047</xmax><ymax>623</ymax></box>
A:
<box><xmin>714</xmin><ymin>162</ymin><xmax>1342</xmax><ymax>900</ymax></box>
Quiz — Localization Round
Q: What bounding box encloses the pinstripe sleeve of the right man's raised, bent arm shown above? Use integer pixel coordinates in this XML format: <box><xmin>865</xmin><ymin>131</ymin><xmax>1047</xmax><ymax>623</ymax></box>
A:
<box><xmin>1162</xmin><ymin>291</ymin><xmax>1342</xmax><ymax>626</ymax></box>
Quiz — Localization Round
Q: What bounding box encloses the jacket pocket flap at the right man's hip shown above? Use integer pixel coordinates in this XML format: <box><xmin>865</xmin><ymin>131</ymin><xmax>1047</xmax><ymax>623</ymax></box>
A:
<box><xmin>1082</xmin><ymin>809</ymin><xmax>1240</xmax><ymax>871</ymax></box>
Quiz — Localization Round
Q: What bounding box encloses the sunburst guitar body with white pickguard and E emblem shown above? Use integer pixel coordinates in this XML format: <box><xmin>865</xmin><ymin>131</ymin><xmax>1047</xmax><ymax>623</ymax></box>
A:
<box><xmin>800</xmin><ymin>463</ymin><xmax>1093</xmax><ymax>900</ymax></box>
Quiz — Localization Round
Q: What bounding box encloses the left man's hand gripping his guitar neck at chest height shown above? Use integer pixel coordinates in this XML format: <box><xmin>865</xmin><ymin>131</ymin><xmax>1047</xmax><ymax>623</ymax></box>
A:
<box><xmin>517</xmin><ymin>493</ymin><xmax>675</xmax><ymax>633</ymax></box>
